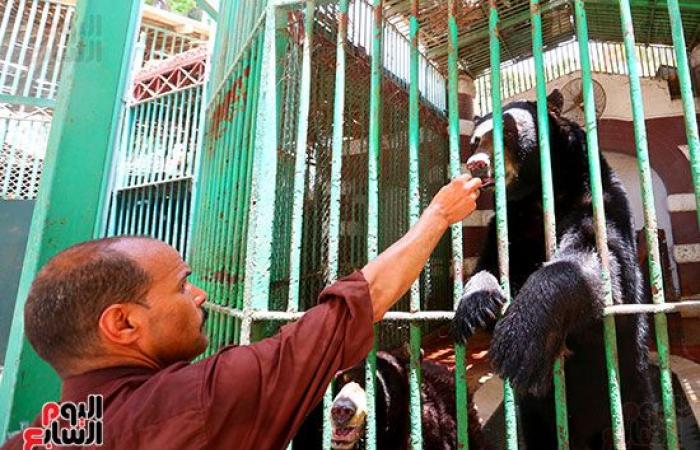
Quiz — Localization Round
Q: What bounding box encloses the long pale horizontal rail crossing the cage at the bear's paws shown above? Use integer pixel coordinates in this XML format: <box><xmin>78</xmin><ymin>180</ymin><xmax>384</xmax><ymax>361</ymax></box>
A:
<box><xmin>204</xmin><ymin>300</ymin><xmax>700</xmax><ymax>322</ymax></box>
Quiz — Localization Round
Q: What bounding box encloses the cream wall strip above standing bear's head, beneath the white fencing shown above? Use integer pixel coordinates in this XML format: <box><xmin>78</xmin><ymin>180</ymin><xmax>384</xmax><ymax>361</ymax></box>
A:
<box><xmin>503</xmin><ymin>70</ymin><xmax>700</xmax><ymax>121</ymax></box>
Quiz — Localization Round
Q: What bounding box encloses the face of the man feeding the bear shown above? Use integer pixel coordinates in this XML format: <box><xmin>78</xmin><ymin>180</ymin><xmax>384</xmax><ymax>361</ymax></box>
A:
<box><xmin>127</xmin><ymin>241</ymin><xmax>207</xmax><ymax>367</ymax></box>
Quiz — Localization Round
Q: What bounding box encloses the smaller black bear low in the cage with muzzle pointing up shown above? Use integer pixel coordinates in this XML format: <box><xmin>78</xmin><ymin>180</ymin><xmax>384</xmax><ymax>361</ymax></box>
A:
<box><xmin>330</xmin><ymin>352</ymin><xmax>485</xmax><ymax>450</ymax></box>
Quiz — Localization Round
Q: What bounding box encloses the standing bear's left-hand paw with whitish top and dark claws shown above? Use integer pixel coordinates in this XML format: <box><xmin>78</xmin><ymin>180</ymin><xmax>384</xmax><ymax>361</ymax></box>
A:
<box><xmin>452</xmin><ymin>270</ymin><xmax>506</xmax><ymax>343</ymax></box>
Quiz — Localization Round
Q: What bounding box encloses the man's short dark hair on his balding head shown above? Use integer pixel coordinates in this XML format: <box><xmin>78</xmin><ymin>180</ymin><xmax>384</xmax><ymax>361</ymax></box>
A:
<box><xmin>24</xmin><ymin>237</ymin><xmax>151</xmax><ymax>373</ymax></box>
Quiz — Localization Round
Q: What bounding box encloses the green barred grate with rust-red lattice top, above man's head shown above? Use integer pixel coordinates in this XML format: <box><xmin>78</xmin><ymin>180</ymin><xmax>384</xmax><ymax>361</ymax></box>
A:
<box><xmin>106</xmin><ymin>49</ymin><xmax>206</xmax><ymax>255</ymax></box>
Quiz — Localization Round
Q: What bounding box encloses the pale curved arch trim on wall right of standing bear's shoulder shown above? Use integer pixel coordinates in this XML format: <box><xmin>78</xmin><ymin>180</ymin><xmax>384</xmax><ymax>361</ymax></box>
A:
<box><xmin>603</xmin><ymin>151</ymin><xmax>679</xmax><ymax>289</ymax></box>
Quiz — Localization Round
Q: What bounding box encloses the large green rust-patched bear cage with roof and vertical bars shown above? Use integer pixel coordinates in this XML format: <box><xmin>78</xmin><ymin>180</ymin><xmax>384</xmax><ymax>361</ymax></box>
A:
<box><xmin>192</xmin><ymin>0</ymin><xmax>700</xmax><ymax>449</ymax></box>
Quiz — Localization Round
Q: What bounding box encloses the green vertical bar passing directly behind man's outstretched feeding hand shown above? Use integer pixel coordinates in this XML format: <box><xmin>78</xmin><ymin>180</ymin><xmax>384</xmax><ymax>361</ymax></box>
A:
<box><xmin>447</xmin><ymin>0</ymin><xmax>469</xmax><ymax>450</ymax></box>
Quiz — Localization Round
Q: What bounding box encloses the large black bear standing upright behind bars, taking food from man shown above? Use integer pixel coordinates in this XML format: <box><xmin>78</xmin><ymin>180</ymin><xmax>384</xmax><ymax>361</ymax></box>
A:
<box><xmin>453</xmin><ymin>91</ymin><xmax>655</xmax><ymax>450</ymax></box>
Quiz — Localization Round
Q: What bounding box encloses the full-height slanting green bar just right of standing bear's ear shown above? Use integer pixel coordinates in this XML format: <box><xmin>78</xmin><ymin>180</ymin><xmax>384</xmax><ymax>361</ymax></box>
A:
<box><xmin>575</xmin><ymin>0</ymin><xmax>626</xmax><ymax>450</ymax></box>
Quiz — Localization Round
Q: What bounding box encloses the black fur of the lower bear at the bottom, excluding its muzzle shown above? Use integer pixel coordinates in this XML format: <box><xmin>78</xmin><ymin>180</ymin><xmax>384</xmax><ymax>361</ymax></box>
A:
<box><xmin>294</xmin><ymin>351</ymin><xmax>486</xmax><ymax>450</ymax></box>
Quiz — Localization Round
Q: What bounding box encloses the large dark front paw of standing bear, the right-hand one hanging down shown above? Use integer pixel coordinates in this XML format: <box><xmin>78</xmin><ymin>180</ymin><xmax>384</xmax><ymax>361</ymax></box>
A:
<box><xmin>489</xmin><ymin>300</ymin><xmax>564</xmax><ymax>397</ymax></box>
